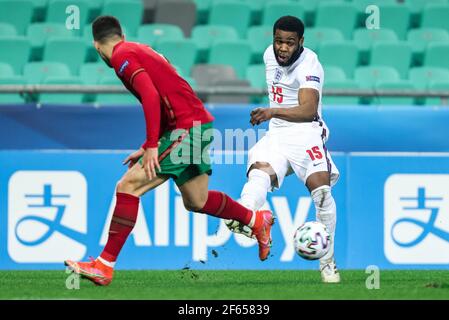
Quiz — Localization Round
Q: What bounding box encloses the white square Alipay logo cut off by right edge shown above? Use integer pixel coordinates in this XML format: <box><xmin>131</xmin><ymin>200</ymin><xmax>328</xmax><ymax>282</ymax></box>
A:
<box><xmin>384</xmin><ymin>174</ymin><xmax>449</xmax><ymax>264</ymax></box>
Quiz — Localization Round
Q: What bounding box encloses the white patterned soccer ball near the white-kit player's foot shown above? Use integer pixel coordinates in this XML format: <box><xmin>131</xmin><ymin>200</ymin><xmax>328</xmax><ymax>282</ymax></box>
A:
<box><xmin>293</xmin><ymin>221</ymin><xmax>330</xmax><ymax>260</ymax></box>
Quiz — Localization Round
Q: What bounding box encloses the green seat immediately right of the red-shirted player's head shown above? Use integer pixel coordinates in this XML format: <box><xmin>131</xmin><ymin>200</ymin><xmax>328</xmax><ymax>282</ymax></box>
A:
<box><xmin>137</xmin><ymin>23</ymin><xmax>184</xmax><ymax>46</ymax></box>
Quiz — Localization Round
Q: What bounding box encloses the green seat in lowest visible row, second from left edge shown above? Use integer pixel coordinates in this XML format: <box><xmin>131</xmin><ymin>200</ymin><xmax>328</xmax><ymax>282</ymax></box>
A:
<box><xmin>23</xmin><ymin>62</ymin><xmax>71</xmax><ymax>84</ymax></box>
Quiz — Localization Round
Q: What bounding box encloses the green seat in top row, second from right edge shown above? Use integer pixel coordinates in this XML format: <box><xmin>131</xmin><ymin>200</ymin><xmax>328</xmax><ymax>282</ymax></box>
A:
<box><xmin>379</xmin><ymin>4</ymin><xmax>410</xmax><ymax>40</ymax></box>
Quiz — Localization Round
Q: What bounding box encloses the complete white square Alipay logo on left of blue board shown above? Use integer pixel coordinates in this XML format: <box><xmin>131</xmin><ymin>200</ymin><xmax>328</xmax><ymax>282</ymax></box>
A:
<box><xmin>8</xmin><ymin>171</ymin><xmax>87</xmax><ymax>263</ymax></box>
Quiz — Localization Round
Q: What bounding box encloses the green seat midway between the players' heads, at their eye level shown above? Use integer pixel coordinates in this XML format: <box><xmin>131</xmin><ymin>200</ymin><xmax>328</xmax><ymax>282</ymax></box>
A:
<box><xmin>192</xmin><ymin>25</ymin><xmax>239</xmax><ymax>62</ymax></box>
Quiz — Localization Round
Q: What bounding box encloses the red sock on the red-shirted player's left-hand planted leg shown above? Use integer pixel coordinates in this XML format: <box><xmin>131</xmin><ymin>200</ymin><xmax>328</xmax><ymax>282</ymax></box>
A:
<box><xmin>100</xmin><ymin>192</ymin><xmax>139</xmax><ymax>262</ymax></box>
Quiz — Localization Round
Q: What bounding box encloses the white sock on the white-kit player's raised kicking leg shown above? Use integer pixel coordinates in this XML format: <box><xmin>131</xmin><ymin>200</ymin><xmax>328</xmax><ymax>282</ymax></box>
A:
<box><xmin>239</xmin><ymin>169</ymin><xmax>271</xmax><ymax>211</ymax></box>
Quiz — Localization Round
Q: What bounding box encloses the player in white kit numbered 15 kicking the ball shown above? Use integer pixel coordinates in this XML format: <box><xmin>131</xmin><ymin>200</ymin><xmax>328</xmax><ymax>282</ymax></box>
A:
<box><xmin>226</xmin><ymin>16</ymin><xmax>340</xmax><ymax>283</ymax></box>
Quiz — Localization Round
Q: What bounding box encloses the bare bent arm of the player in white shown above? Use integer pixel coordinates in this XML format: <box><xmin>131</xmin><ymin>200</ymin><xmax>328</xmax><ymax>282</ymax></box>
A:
<box><xmin>250</xmin><ymin>88</ymin><xmax>320</xmax><ymax>125</ymax></box>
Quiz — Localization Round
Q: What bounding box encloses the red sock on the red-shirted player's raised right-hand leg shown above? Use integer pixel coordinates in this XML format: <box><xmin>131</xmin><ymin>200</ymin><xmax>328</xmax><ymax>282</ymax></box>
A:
<box><xmin>199</xmin><ymin>191</ymin><xmax>253</xmax><ymax>225</ymax></box>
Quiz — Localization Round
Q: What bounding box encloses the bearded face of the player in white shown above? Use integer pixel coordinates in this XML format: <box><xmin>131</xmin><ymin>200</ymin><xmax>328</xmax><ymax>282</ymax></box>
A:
<box><xmin>273</xmin><ymin>29</ymin><xmax>304</xmax><ymax>66</ymax></box>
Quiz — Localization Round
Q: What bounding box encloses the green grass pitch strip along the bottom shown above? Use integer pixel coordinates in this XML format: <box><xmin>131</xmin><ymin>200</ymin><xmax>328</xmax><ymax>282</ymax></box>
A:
<box><xmin>0</xmin><ymin>270</ymin><xmax>449</xmax><ymax>300</ymax></box>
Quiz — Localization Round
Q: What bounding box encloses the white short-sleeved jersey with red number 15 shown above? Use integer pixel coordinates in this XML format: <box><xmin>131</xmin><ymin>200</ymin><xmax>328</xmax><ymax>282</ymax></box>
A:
<box><xmin>263</xmin><ymin>45</ymin><xmax>324</xmax><ymax>130</ymax></box>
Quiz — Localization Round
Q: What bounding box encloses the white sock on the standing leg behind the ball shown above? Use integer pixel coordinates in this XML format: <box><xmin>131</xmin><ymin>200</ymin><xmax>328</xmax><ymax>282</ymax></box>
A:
<box><xmin>311</xmin><ymin>185</ymin><xmax>337</xmax><ymax>263</ymax></box>
